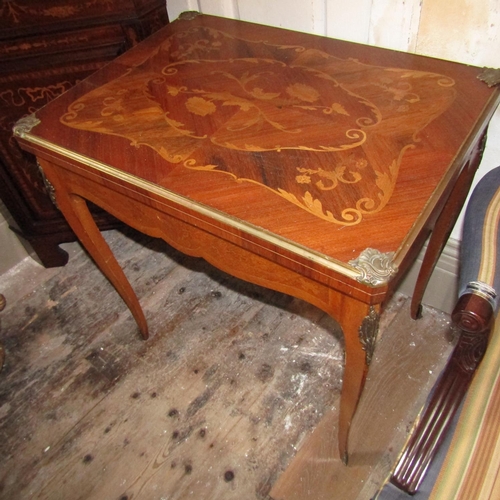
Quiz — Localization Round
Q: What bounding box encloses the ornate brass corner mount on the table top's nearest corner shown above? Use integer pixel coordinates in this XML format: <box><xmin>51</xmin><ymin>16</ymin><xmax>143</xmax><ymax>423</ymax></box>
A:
<box><xmin>349</xmin><ymin>248</ymin><xmax>398</xmax><ymax>286</ymax></box>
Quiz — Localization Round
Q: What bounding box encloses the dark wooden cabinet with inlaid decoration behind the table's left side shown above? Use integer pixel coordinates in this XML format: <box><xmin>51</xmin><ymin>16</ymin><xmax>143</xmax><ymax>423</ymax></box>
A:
<box><xmin>0</xmin><ymin>0</ymin><xmax>168</xmax><ymax>267</ymax></box>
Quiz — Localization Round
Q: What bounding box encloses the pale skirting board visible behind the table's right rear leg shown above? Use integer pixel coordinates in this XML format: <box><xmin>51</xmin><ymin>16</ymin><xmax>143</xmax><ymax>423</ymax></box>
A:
<box><xmin>398</xmin><ymin>238</ymin><xmax>460</xmax><ymax>314</ymax></box>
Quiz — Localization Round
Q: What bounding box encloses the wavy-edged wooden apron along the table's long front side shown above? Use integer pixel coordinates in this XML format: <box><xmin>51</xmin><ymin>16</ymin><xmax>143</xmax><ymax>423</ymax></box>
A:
<box><xmin>41</xmin><ymin>158</ymin><xmax>387</xmax><ymax>313</ymax></box>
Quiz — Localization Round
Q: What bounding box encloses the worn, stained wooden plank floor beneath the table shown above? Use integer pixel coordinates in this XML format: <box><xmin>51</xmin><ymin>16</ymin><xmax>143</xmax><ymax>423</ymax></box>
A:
<box><xmin>0</xmin><ymin>231</ymin><xmax>452</xmax><ymax>500</ymax></box>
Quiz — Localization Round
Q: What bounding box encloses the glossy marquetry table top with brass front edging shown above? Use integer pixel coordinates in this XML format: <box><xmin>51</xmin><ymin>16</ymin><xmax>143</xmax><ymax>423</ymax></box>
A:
<box><xmin>18</xmin><ymin>14</ymin><xmax>498</xmax><ymax>282</ymax></box>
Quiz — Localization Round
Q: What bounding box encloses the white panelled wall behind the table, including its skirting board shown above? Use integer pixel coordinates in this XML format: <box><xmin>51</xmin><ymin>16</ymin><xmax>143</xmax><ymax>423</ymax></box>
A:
<box><xmin>167</xmin><ymin>0</ymin><xmax>500</xmax><ymax>312</ymax></box>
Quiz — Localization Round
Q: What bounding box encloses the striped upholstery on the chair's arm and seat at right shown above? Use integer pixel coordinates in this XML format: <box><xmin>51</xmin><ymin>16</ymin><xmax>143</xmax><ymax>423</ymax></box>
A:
<box><xmin>430</xmin><ymin>167</ymin><xmax>500</xmax><ymax>500</ymax></box>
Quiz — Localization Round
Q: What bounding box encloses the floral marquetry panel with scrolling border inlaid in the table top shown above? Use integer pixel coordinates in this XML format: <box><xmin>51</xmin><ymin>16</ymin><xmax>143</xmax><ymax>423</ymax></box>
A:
<box><xmin>61</xmin><ymin>26</ymin><xmax>456</xmax><ymax>226</ymax></box>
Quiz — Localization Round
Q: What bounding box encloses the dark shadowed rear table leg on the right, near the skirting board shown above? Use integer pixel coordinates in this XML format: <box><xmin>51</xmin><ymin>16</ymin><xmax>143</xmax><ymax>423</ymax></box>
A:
<box><xmin>410</xmin><ymin>136</ymin><xmax>485</xmax><ymax>319</ymax></box>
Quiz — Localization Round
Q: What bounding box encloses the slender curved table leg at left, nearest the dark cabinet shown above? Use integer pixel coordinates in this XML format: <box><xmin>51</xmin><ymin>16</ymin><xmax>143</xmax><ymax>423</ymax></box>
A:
<box><xmin>38</xmin><ymin>159</ymin><xmax>149</xmax><ymax>339</ymax></box>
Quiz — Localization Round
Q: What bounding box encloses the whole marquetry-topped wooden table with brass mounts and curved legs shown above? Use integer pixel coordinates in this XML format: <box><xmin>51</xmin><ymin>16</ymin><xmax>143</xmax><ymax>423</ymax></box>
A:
<box><xmin>15</xmin><ymin>13</ymin><xmax>499</xmax><ymax>462</ymax></box>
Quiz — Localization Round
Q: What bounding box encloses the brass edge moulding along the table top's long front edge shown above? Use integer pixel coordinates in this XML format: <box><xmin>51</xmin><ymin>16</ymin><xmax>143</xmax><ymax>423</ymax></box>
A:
<box><xmin>10</xmin><ymin>127</ymin><xmax>365</xmax><ymax>283</ymax></box>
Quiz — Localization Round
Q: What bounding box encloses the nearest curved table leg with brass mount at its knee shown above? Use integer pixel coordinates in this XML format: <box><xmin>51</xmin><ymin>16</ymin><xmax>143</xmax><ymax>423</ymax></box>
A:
<box><xmin>337</xmin><ymin>298</ymin><xmax>379</xmax><ymax>464</ymax></box>
